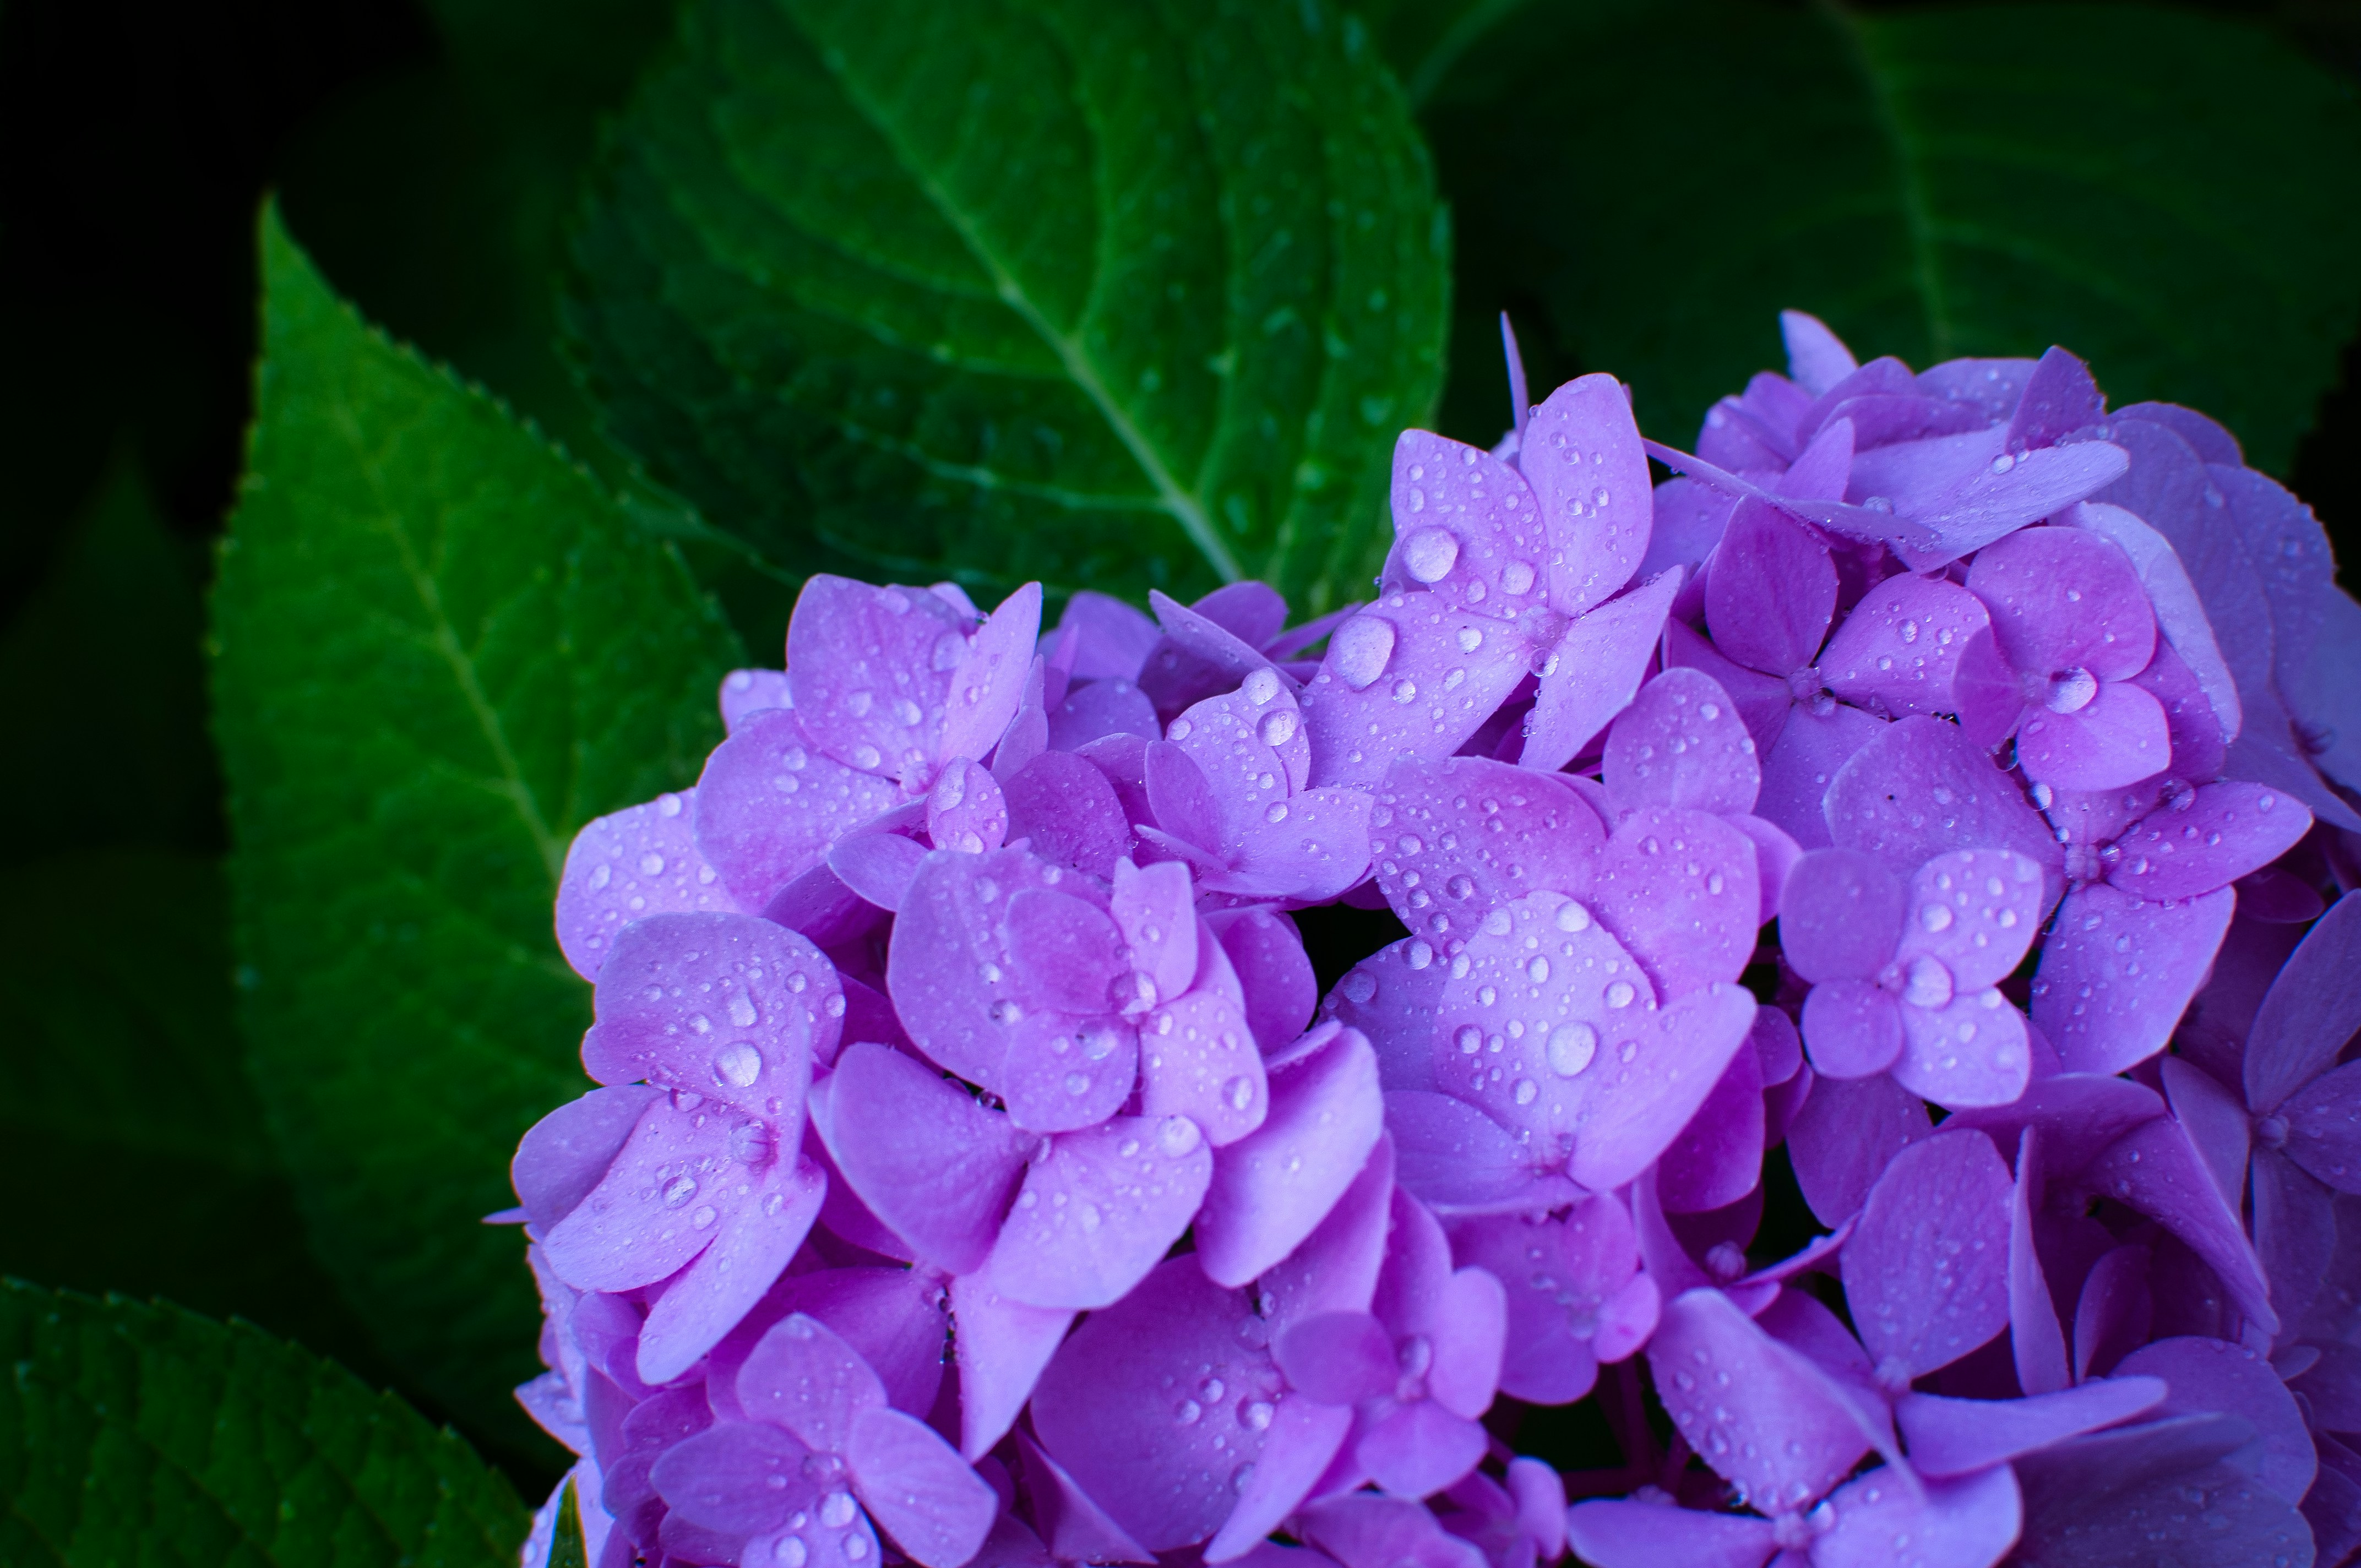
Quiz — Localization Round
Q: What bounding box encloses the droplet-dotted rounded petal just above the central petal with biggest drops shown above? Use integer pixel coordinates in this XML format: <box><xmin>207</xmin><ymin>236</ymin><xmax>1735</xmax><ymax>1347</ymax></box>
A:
<box><xmin>1369</xmin><ymin>758</ymin><xmax>1606</xmax><ymax>940</ymax></box>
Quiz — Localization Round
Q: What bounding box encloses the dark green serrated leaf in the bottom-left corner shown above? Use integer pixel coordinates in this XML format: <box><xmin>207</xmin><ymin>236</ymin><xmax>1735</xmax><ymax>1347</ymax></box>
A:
<box><xmin>0</xmin><ymin>1280</ymin><xmax>529</xmax><ymax>1568</ymax></box>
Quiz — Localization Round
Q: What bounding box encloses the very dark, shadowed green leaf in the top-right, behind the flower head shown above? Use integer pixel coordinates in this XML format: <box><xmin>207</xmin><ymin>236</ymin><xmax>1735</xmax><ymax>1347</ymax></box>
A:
<box><xmin>1424</xmin><ymin>0</ymin><xmax>2361</xmax><ymax>470</ymax></box>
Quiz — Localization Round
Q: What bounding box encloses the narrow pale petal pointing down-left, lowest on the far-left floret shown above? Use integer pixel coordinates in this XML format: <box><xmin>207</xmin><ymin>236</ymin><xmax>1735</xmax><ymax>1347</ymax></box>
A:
<box><xmin>638</xmin><ymin>1159</ymin><xmax>829</xmax><ymax>1386</ymax></box>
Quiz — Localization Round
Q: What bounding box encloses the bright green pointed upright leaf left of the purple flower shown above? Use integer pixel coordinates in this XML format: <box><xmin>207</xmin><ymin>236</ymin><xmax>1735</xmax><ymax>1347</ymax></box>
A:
<box><xmin>213</xmin><ymin>215</ymin><xmax>741</xmax><ymax>1443</ymax></box>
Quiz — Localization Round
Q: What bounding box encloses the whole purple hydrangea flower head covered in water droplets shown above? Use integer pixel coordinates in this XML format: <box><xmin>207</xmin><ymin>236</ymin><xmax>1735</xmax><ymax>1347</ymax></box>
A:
<box><xmin>512</xmin><ymin>314</ymin><xmax>2361</xmax><ymax>1568</ymax></box>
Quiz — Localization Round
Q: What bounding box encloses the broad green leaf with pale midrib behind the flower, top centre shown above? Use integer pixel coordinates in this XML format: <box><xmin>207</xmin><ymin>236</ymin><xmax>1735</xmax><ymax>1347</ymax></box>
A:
<box><xmin>569</xmin><ymin>0</ymin><xmax>1450</xmax><ymax>609</ymax></box>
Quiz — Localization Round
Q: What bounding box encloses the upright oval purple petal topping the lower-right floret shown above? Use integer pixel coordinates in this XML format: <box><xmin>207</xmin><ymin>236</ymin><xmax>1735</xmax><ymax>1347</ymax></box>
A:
<box><xmin>1844</xmin><ymin>1131</ymin><xmax>2011</xmax><ymax>1386</ymax></box>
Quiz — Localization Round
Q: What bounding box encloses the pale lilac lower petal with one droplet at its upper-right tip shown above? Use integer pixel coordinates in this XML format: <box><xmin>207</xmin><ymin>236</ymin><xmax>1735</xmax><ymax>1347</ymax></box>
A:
<box><xmin>992</xmin><ymin>1117</ymin><xmax>1214</xmax><ymax>1310</ymax></box>
